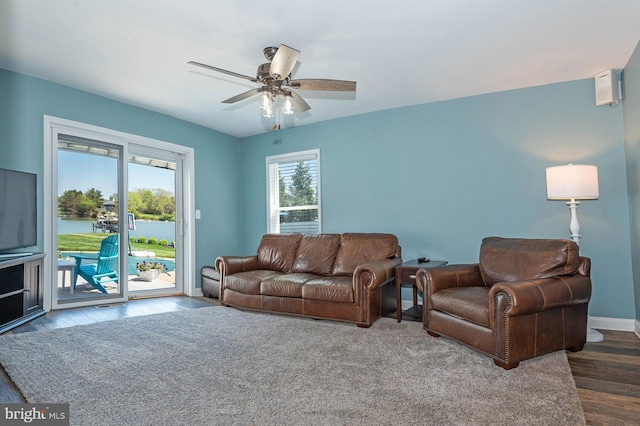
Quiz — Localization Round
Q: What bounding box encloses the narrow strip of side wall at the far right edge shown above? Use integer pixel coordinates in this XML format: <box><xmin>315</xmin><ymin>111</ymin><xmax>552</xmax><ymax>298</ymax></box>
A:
<box><xmin>622</xmin><ymin>43</ymin><xmax>640</xmax><ymax>320</ymax></box>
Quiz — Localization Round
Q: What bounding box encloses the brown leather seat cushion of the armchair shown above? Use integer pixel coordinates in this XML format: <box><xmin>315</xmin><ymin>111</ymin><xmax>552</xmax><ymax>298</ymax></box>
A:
<box><xmin>431</xmin><ymin>287</ymin><xmax>490</xmax><ymax>327</ymax></box>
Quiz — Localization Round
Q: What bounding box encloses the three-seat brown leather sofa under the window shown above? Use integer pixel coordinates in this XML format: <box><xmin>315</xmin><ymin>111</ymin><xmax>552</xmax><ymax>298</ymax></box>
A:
<box><xmin>216</xmin><ymin>234</ymin><xmax>402</xmax><ymax>327</ymax></box>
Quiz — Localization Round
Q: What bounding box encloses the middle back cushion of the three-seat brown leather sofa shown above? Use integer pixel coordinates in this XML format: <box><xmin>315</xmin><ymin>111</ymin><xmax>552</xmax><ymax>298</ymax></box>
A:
<box><xmin>291</xmin><ymin>234</ymin><xmax>340</xmax><ymax>275</ymax></box>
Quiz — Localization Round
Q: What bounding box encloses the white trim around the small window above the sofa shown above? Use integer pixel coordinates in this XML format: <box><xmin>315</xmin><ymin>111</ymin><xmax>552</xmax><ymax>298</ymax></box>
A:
<box><xmin>265</xmin><ymin>149</ymin><xmax>322</xmax><ymax>234</ymax></box>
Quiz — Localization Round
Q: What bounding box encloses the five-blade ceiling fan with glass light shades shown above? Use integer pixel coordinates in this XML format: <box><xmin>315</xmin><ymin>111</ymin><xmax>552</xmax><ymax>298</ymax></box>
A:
<box><xmin>189</xmin><ymin>44</ymin><xmax>356</xmax><ymax>117</ymax></box>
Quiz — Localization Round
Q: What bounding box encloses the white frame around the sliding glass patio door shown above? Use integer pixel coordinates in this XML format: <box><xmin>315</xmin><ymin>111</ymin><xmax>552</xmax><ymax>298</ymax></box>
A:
<box><xmin>42</xmin><ymin>115</ymin><xmax>202</xmax><ymax>312</ymax></box>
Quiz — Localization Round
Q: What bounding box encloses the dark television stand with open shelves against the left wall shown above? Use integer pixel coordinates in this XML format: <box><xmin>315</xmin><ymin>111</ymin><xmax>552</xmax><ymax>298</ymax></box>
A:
<box><xmin>0</xmin><ymin>253</ymin><xmax>45</xmax><ymax>334</ymax></box>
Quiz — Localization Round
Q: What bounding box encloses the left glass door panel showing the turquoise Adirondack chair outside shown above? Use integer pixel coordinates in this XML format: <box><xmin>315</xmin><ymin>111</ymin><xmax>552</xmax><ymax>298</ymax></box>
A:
<box><xmin>55</xmin><ymin>133</ymin><xmax>127</xmax><ymax>305</ymax></box>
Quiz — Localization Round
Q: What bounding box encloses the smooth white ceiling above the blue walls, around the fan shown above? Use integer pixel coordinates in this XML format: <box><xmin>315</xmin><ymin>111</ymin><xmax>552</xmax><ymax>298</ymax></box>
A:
<box><xmin>0</xmin><ymin>0</ymin><xmax>640</xmax><ymax>137</ymax></box>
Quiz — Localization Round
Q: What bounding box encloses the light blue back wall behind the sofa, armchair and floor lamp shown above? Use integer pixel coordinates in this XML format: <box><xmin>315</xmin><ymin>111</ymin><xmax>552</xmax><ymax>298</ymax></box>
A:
<box><xmin>241</xmin><ymin>79</ymin><xmax>635</xmax><ymax>318</ymax></box>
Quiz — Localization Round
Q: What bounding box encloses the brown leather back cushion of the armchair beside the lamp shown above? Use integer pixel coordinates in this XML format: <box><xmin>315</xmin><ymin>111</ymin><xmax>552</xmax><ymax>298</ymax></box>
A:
<box><xmin>480</xmin><ymin>237</ymin><xmax>580</xmax><ymax>287</ymax></box>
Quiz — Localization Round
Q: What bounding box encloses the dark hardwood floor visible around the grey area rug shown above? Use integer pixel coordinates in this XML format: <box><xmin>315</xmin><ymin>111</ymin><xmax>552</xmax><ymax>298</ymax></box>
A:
<box><xmin>0</xmin><ymin>297</ymin><xmax>640</xmax><ymax>425</ymax></box>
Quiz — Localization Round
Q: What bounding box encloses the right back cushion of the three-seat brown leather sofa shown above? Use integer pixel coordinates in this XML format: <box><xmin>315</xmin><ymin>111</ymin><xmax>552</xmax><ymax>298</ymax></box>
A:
<box><xmin>331</xmin><ymin>234</ymin><xmax>398</xmax><ymax>275</ymax></box>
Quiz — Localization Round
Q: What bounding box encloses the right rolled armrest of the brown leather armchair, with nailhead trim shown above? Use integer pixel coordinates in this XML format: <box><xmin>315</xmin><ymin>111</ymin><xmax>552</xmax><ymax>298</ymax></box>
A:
<box><xmin>489</xmin><ymin>275</ymin><xmax>591</xmax><ymax>326</ymax></box>
